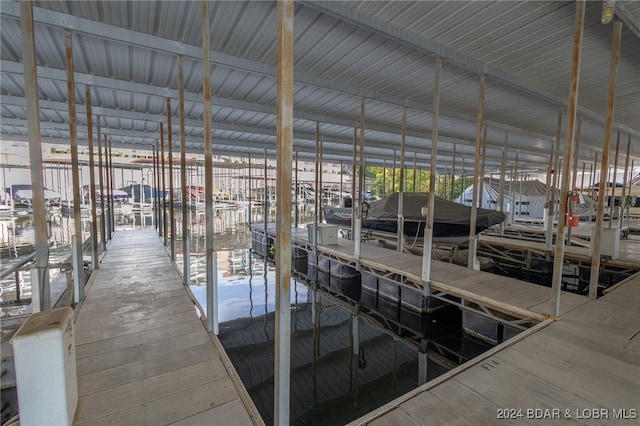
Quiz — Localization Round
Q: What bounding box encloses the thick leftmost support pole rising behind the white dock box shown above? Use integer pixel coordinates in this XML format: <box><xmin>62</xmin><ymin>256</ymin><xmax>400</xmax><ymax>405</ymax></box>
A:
<box><xmin>20</xmin><ymin>1</ymin><xmax>51</xmax><ymax>312</ymax></box>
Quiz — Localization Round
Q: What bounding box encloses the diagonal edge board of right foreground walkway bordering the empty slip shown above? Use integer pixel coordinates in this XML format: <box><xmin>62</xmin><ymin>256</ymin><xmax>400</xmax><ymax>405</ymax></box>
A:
<box><xmin>347</xmin><ymin>319</ymin><xmax>555</xmax><ymax>426</ymax></box>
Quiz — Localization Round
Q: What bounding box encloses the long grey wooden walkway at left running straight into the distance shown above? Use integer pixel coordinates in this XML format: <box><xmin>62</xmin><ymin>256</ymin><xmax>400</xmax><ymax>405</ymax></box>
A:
<box><xmin>74</xmin><ymin>230</ymin><xmax>264</xmax><ymax>425</ymax></box>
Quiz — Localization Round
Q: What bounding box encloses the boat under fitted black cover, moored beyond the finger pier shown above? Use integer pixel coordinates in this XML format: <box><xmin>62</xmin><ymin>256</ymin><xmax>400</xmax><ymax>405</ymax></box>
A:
<box><xmin>324</xmin><ymin>192</ymin><xmax>506</xmax><ymax>240</ymax></box>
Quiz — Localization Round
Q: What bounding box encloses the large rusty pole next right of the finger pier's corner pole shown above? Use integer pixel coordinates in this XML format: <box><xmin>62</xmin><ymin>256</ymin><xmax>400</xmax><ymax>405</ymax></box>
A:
<box><xmin>583</xmin><ymin>19</ymin><xmax>622</xmax><ymax>299</ymax></box>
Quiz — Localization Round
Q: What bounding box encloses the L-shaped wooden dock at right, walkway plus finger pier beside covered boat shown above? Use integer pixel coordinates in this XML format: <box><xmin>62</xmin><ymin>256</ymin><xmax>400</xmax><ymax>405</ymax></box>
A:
<box><xmin>252</xmin><ymin>225</ymin><xmax>640</xmax><ymax>425</ymax></box>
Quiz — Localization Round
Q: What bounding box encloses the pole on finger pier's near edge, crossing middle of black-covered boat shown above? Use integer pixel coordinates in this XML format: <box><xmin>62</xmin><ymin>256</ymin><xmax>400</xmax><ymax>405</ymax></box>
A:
<box><xmin>421</xmin><ymin>58</ymin><xmax>442</xmax><ymax>292</ymax></box>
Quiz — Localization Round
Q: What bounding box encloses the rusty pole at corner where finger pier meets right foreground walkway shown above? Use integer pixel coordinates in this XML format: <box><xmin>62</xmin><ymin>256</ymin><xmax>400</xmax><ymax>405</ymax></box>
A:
<box><xmin>550</xmin><ymin>0</ymin><xmax>586</xmax><ymax>317</ymax></box>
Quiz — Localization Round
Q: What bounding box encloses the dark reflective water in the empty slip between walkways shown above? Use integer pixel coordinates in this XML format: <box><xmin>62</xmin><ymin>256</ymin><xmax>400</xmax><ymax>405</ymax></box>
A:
<box><xmin>191</xmin><ymin>255</ymin><xmax>491</xmax><ymax>425</ymax></box>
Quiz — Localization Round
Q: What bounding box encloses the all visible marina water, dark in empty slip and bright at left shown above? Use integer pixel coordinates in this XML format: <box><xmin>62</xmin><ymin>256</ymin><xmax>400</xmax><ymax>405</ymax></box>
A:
<box><xmin>0</xmin><ymin>209</ymin><xmax>496</xmax><ymax>425</ymax></box>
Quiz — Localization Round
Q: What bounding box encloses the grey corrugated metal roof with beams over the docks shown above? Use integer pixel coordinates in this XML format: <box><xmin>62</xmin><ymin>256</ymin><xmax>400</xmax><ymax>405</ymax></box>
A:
<box><xmin>0</xmin><ymin>1</ymin><xmax>640</xmax><ymax>169</ymax></box>
